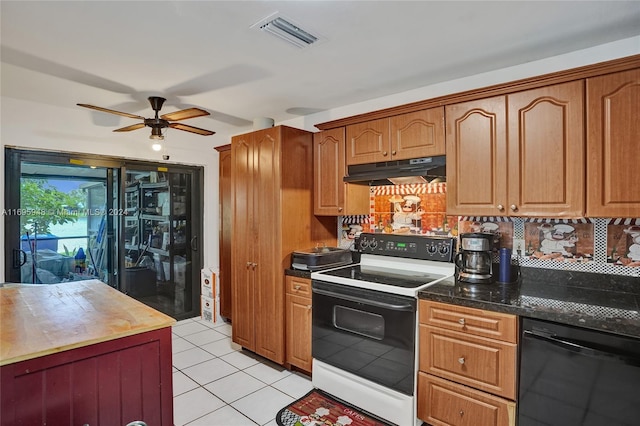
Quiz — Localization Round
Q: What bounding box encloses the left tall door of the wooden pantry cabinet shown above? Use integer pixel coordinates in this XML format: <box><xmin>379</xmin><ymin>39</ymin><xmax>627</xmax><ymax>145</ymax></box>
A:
<box><xmin>231</xmin><ymin>135</ymin><xmax>256</xmax><ymax>350</ymax></box>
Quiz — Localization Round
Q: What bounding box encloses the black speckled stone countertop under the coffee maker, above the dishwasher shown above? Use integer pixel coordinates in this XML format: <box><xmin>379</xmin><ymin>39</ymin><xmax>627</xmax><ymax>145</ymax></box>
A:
<box><xmin>418</xmin><ymin>267</ymin><xmax>640</xmax><ymax>338</ymax></box>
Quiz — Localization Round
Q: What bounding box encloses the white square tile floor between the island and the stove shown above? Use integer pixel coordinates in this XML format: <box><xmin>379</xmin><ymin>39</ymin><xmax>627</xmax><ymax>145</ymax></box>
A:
<box><xmin>172</xmin><ymin>318</ymin><xmax>312</xmax><ymax>426</ymax></box>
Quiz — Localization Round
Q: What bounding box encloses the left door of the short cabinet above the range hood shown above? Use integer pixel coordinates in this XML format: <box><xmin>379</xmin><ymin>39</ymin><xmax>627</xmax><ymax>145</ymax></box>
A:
<box><xmin>346</xmin><ymin>118</ymin><xmax>392</xmax><ymax>166</ymax></box>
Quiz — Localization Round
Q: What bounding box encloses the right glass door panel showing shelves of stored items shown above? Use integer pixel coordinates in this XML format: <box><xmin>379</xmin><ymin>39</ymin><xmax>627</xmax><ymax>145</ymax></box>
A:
<box><xmin>122</xmin><ymin>168</ymin><xmax>200</xmax><ymax>317</ymax></box>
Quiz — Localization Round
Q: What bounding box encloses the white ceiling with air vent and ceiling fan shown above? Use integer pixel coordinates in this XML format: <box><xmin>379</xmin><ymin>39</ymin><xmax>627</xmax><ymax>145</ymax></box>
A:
<box><xmin>0</xmin><ymin>0</ymin><xmax>640</xmax><ymax>143</ymax></box>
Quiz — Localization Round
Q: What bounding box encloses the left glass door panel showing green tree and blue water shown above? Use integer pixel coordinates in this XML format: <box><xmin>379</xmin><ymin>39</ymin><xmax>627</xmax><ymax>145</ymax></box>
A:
<box><xmin>5</xmin><ymin>151</ymin><xmax>118</xmax><ymax>287</ymax></box>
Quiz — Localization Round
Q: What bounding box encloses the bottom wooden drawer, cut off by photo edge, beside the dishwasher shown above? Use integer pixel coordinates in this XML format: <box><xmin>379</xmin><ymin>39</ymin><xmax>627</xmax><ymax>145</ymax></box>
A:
<box><xmin>418</xmin><ymin>372</ymin><xmax>516</xmax><ymax>426</ymax></box>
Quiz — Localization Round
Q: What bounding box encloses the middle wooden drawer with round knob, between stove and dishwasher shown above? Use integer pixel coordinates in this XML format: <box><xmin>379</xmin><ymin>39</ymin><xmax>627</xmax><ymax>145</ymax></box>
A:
<box><xmin>420</xmin><ymin>324</ymin><xmax>517</xmax><ymax>400</ymax></box>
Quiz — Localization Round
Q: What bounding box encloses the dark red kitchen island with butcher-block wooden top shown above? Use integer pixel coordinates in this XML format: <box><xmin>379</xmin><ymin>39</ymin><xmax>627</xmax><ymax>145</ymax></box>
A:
<box><xmin>0</xmin><ymin>280</ymin><xmax>175</xmax><ymax>426</ymax></box>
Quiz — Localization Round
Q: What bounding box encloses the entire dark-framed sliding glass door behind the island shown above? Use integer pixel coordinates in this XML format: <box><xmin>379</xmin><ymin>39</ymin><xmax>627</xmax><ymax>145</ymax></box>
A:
<box><xmin>4</xmin><ymin>148</ymin><xmax>203</xmax><ymax>319</ymax></box>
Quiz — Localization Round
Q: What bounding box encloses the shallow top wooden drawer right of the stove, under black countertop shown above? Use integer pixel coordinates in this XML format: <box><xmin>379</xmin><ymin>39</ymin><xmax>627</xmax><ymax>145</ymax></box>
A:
<box><xmin>420</xmin><ymin>300</ymin><xmax>518</xmax><ymax>343</ymax></box>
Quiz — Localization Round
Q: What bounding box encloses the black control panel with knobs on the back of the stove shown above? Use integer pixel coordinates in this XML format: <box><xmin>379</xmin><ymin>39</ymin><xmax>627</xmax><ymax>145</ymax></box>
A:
<box><xmin>358</xmin><ymin>232</ymin><xmax>456</xmax><ymax>262</ymax></box>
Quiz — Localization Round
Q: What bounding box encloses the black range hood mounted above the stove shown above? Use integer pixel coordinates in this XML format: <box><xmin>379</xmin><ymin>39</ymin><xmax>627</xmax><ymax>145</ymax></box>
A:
<box><xmin>344</xmin><ymin>155</ymin><xmax>446</xmax><ymax>186</ymax></box>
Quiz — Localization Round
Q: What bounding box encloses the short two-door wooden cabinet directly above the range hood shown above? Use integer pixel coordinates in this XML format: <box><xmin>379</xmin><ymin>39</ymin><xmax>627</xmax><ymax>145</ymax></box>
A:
<box><xmin>346</xmin><ymin>107</ymin><xmax>445</xmax><ymax>166</ymax></box>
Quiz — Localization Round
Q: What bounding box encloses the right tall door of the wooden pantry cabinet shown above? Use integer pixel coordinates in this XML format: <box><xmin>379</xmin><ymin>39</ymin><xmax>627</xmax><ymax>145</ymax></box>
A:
<box><xmin>251</xmin><ymin>127</ymin><xmax>284</xmax><ymax>364</ymax></box>
